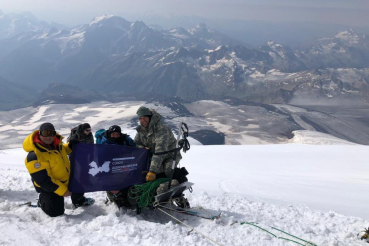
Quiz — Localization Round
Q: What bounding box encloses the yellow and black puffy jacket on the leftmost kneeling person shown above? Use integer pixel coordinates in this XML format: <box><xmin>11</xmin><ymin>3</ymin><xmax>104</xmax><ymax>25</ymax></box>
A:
<box><xmin>23</xmin><ymin>130</ymin><xmax>72</xmax><ymax>196</ymax></box>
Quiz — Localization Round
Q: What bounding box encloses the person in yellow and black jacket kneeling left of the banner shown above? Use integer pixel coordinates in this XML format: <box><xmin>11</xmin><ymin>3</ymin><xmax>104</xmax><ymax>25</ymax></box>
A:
<box><xmin>23</xmin><ymin>123</ymin><xmax>94</xmax><ymax>217</ymax></box>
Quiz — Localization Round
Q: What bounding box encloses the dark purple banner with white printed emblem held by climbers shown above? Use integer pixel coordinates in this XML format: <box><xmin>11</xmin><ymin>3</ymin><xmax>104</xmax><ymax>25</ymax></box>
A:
<box><xmin>69</xmin><ymin>143</ymin><xmax>150</xmax><ymax>193</ymax></box>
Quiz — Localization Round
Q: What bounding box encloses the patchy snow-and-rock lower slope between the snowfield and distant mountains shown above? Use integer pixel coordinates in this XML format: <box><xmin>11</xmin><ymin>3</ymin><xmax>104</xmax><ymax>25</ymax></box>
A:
<box><xmin>0</xmin><ymin>99</ymin><xmax>369</xmax><ymax>149</ymax></box>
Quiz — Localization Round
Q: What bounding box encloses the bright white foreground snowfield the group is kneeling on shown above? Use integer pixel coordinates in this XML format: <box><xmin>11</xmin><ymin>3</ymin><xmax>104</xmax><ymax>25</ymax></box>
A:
<box><xmin>0</xmin><ymin>140</ymin><xmax>369</xmax><ymax>246</ymax></box>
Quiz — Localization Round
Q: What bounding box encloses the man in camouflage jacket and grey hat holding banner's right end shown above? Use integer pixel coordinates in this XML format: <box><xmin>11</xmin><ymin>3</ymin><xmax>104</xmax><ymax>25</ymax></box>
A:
<box><xmin>134</xmin><ymin>106</ymin><xmax>182</xmax><ymax>181</ymax></box>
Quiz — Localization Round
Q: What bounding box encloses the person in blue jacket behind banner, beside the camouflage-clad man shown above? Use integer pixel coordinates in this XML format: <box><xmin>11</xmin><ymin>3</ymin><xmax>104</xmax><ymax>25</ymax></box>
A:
<box><xmin>95</xmin><ymin>125</ymin><xmax>136</xmax><ymax>208</ymax></box>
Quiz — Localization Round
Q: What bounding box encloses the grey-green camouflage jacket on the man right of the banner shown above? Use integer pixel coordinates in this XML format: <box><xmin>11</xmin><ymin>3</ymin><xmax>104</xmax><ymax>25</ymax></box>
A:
<box><xmin>134</xmin><ymin>109</ymin><xmax>182</xmax><ymax>174</ymax></box>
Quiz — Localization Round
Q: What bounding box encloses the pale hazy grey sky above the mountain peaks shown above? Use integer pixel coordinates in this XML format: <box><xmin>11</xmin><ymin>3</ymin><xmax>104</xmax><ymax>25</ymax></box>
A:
<box><xmin>0</xmin><ymin>0</ymin><xmax>369</xmax><ymax>26</ymax></box>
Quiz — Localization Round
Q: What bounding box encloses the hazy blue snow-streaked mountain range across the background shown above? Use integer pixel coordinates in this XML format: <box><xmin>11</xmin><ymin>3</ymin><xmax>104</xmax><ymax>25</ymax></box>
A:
<box><xmin>0</xmin><ymin>13</ymin><xmax>369</xmax><ymax>109</ymax></box>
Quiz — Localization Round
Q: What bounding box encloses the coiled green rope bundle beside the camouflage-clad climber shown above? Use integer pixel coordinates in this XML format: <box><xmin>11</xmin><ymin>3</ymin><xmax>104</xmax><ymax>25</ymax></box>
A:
<box><xmin>128</xmin><ymin>178</ymin><xmax>169</xmax><ymax>208</ymax></box>
